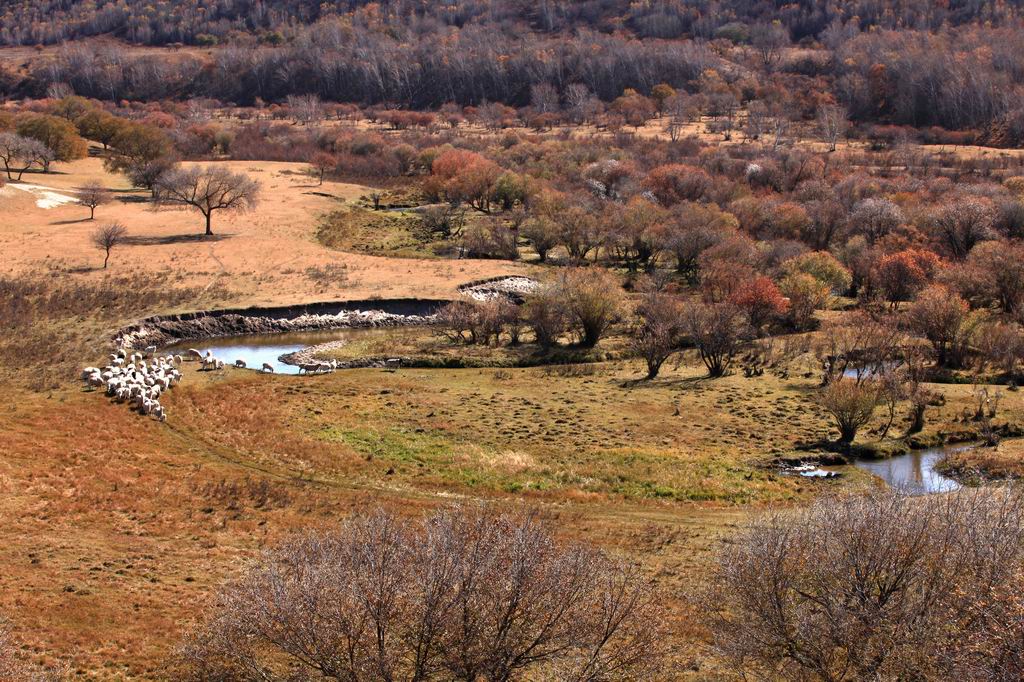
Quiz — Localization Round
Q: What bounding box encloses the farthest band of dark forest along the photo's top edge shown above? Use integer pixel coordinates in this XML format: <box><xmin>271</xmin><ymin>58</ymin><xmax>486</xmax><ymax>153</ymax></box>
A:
<box><xmin>0</xmin><ymin>0</ymin><xmax>1020</xmax><ymax>45</ymax></box>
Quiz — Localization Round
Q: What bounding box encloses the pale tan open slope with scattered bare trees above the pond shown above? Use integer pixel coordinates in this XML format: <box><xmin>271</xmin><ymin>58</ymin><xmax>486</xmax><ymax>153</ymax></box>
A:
<box><xmin>0</xmin><ymin>158</ymin><xmax>528</xmax><ymax>305</ymax></box>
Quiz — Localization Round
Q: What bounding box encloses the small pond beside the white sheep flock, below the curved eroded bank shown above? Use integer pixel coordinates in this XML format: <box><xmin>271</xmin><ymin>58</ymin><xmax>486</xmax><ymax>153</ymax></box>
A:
<box><xmin>161</xmin><ymin>329</ymin><xmax>375</xmax><ymax>374</ymax></box>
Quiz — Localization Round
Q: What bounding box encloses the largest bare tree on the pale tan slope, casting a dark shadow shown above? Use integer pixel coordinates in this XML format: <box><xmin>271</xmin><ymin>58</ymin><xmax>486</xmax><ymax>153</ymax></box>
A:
<box><xmin>156</xmin><ymin>166</ymin><xmax>260</xmax><ymax>235</ymax></box>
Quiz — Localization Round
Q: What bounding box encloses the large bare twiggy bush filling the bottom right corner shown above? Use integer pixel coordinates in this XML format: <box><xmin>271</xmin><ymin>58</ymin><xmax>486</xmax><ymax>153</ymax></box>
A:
<box><xmin>701</xmin><ymin>488</ymin><xmax>1024</xmax><ymax>682</ymax></box>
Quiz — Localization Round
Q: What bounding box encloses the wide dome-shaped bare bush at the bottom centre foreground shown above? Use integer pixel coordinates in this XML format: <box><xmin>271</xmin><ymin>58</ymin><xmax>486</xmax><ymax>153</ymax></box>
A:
<box><xmin>176</xmin><ymin>506</ymin><xmax>659</xmax><ymax>682</ymax></box>
